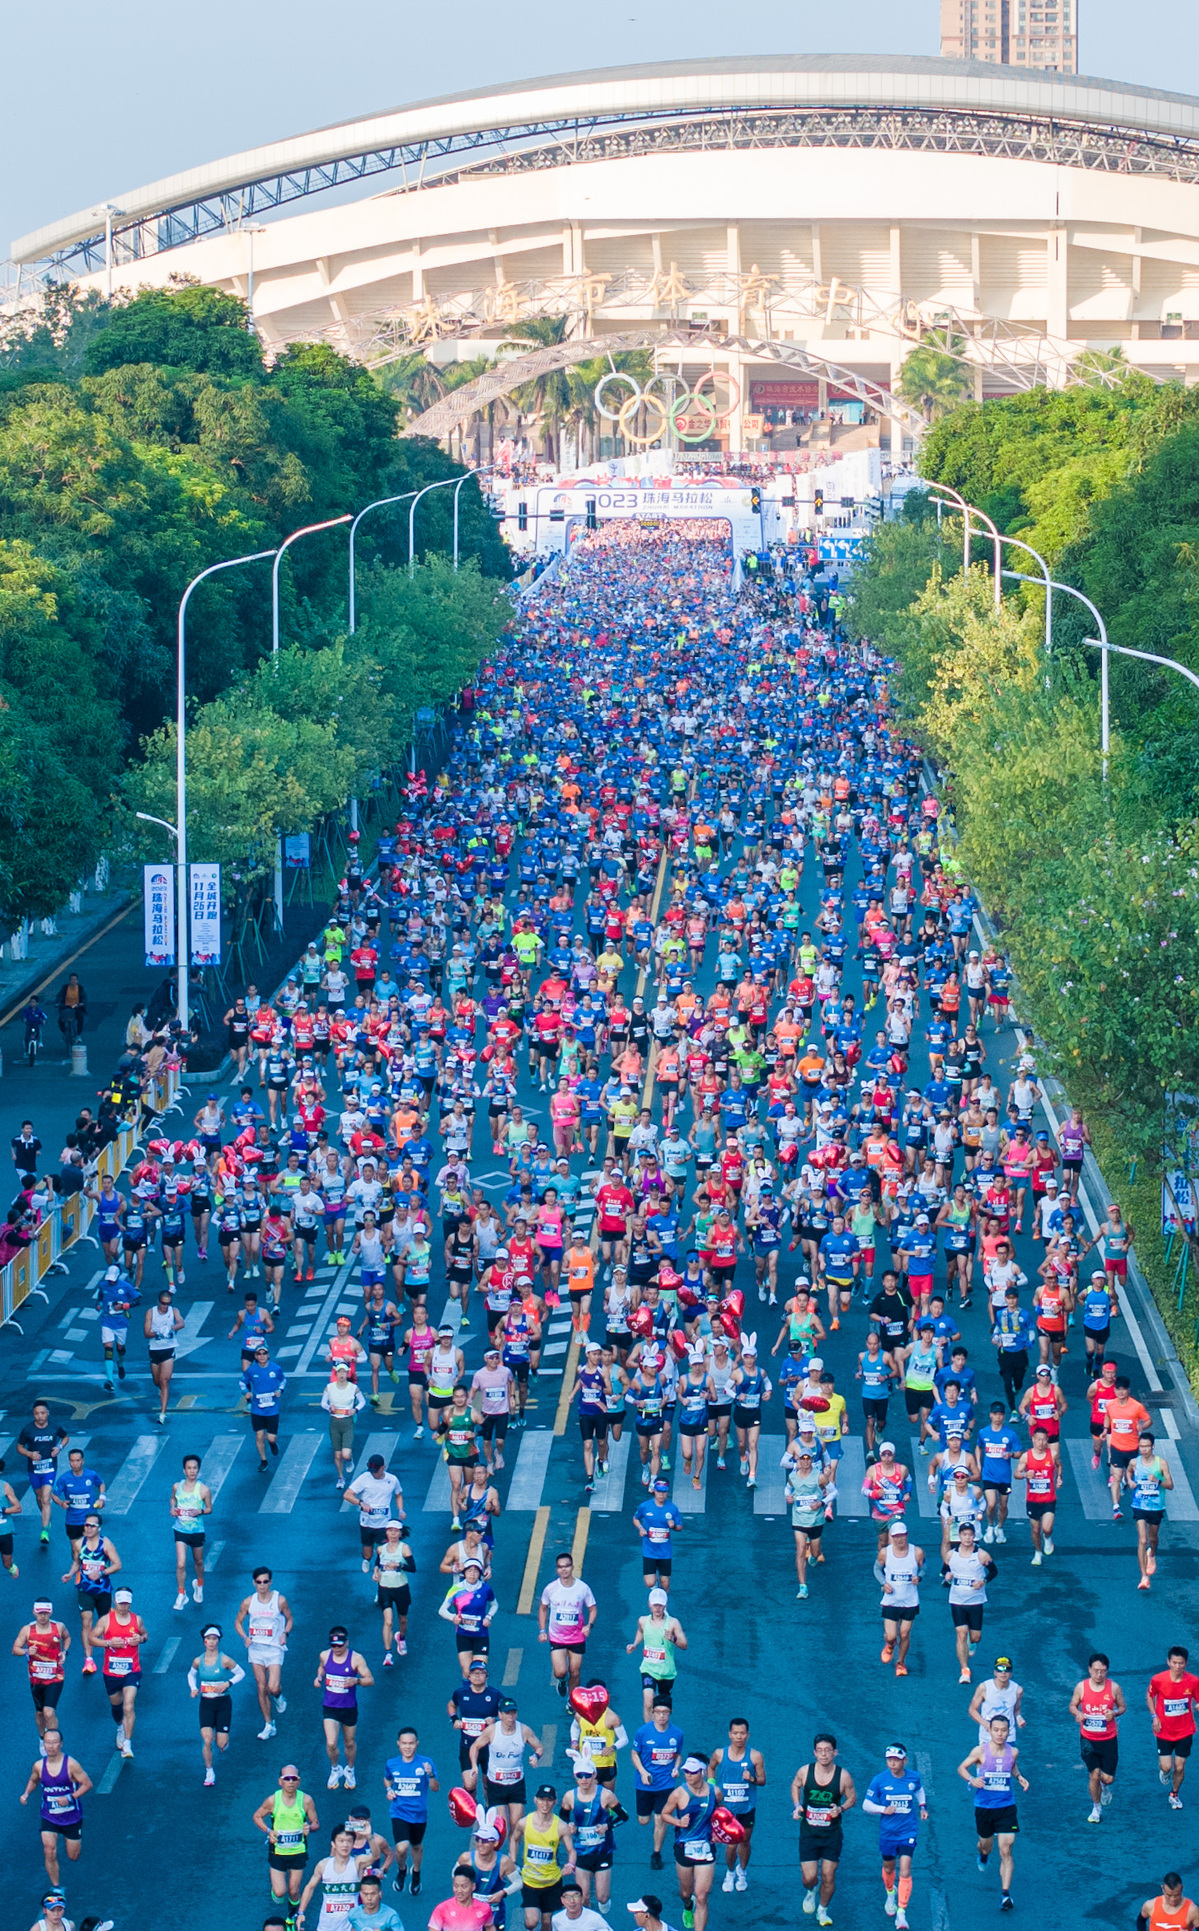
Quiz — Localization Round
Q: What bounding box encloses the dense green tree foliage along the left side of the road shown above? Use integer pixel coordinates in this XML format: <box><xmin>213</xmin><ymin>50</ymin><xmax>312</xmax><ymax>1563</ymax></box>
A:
<box><xmin>0</xmin><ymin>282</ymin><xmax>510</xmax><ymax>923</ymax></box>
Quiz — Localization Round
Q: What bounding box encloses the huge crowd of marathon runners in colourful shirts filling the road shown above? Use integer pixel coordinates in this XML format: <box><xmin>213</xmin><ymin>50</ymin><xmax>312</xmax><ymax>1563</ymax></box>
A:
<box><xmin>0</xmin><ymin>523</ymin><xmax>1199</xmax><ymax>1931</ymax></box>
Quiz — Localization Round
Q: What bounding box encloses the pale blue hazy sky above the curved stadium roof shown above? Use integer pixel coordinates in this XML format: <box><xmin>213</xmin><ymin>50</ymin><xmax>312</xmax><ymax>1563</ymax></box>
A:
<box><xmin>0</xmin><ymin>0</ymin><xmax>1199</xmax><ymax>255</ymax></box>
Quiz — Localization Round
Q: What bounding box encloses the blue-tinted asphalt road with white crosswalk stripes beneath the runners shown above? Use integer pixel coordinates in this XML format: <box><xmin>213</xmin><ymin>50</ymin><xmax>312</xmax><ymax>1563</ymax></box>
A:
<box><xmin>0</xmin><ymin>803</ymin><xmax>1199</xmax><ymax>1931</ymax></box>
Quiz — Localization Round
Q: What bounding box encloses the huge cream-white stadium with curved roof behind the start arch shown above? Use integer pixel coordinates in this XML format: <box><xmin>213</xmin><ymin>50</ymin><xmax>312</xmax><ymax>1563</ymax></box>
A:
<box><xmin>14</xmin><ymin>56</ymin><xmax>1199</xmax><ymax>448</ymax></box>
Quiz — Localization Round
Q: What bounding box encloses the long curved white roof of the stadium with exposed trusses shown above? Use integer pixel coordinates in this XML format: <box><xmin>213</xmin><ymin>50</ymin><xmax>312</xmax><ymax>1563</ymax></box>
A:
<box><xmin>12</xmin><ymin>54</ymin><xmax>1199</xmax><ymax>263</ymax></box>
